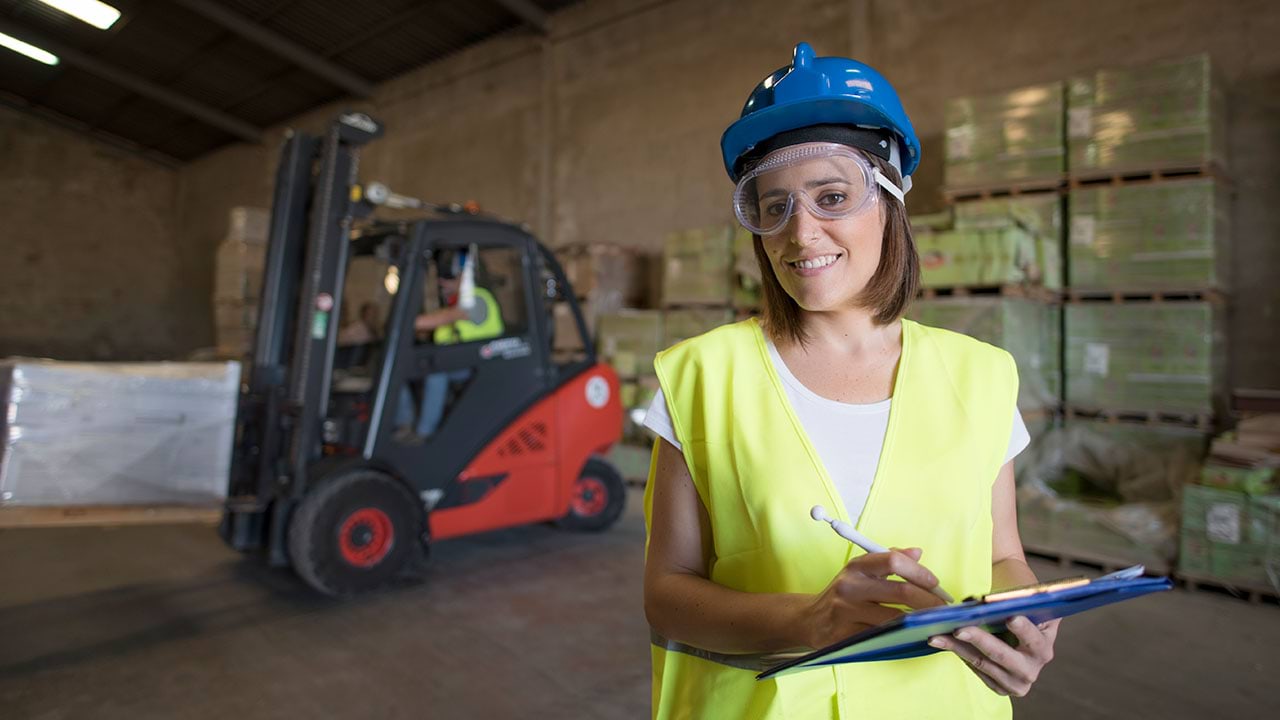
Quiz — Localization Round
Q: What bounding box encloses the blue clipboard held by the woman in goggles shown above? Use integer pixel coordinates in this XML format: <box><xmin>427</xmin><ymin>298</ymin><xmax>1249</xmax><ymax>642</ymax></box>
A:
<box><xmin>756</xmin><ymin>566</ymin><xmax>1174</xmax><ymax>680</ymax></box>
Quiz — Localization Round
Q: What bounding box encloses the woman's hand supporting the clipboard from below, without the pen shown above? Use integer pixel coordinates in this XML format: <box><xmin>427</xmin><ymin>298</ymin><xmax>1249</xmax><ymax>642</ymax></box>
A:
<box><xmin>929</xmin><ymin>616</ymin><xmax>1061</xmax><ymax>697</ymax></box>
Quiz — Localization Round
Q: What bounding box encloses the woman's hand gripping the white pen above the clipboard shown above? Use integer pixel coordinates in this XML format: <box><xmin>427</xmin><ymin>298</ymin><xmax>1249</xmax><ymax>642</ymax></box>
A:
<box><xmin>805</xmin><ymin>547</ymin><xmax>945</xmax><ymax>648</ymax></box>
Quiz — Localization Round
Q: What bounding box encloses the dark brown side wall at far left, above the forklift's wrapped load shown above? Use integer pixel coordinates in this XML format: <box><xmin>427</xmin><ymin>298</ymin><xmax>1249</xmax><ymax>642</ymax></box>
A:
<box><xmin>0</xmin><ymin>106</ymin><xmax>181</xmax><ymax>360</ymax></box>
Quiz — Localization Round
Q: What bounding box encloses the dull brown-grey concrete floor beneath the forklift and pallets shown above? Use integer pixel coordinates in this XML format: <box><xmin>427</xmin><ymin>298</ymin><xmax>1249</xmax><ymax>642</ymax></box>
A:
<box><xmin>0</xmin><ymin>484</ymin><xmax>1280</xmax><ymax>720</ymax></box>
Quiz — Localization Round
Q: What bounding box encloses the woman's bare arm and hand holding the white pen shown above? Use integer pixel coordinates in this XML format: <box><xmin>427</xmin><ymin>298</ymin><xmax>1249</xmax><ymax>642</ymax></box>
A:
<box><xmin>644</xmin><ymin>439</ymin><xmax>940</xmax><ymax>653</ymax></box>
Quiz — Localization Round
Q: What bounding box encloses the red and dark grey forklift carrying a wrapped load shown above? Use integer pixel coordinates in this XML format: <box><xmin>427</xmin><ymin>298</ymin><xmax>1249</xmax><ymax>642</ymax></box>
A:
<box><xmin>219</xmin><ymin>113</ymin><xmax>626</xmax><ymax>596</ymax></box>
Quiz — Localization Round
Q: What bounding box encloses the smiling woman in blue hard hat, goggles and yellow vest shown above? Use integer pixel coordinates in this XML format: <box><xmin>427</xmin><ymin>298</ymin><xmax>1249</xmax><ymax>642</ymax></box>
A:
<box><xmin>644</xmin><ymin>44</ymin><xmax>1057</xmax><ymax>720</ymax></box>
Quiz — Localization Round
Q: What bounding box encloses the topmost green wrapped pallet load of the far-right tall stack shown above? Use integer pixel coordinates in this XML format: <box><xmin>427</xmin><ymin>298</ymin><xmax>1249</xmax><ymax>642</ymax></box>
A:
<box><xmin>1066</xmin><ymin>55</ymin><xmax>1226</xmax><ymax>176</ymax></box>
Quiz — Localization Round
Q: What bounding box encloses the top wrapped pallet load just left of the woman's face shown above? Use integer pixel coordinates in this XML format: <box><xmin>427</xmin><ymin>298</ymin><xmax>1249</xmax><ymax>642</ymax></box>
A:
<box><xmin>662</xmin><ymin>224</ymin><xmax>735</xmax><ymax>305</ymax></box>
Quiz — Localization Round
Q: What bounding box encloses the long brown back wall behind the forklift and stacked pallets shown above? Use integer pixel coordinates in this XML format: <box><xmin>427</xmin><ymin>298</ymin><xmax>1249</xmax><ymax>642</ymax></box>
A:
<box><xmin>179</xmin><ymin>0</ymin><xmax>1280</xmax><ymax>387</ymax></box>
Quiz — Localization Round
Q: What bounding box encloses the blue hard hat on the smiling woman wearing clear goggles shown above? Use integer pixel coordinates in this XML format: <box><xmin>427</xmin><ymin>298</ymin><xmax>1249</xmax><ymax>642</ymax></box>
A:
<box><xmin>721</xmin><ymin>42</ymin><xmax>920</xmax><ymax>181</ymax></box>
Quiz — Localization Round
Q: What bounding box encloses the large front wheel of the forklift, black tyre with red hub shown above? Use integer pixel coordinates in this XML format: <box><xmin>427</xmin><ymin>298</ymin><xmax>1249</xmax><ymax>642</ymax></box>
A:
<box><xmin>289</xmin><ymin>468</ymin><xmax>424</xmax><ymax>596</ymax></box>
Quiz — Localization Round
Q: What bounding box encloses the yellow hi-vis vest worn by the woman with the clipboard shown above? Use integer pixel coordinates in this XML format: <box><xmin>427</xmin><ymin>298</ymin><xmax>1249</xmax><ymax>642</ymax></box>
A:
<box><xmin>645</xmin><ymin>319</ymin><xmax>1018</xmax><ymax>720</ymax></box>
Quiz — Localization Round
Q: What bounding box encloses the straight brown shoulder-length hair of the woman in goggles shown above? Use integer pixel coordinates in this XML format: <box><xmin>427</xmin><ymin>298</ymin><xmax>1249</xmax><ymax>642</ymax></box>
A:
<box><xmin>753</xmin><ymin>151</ymin><xmax>920</xmax><ymax>345</ymax></box>
